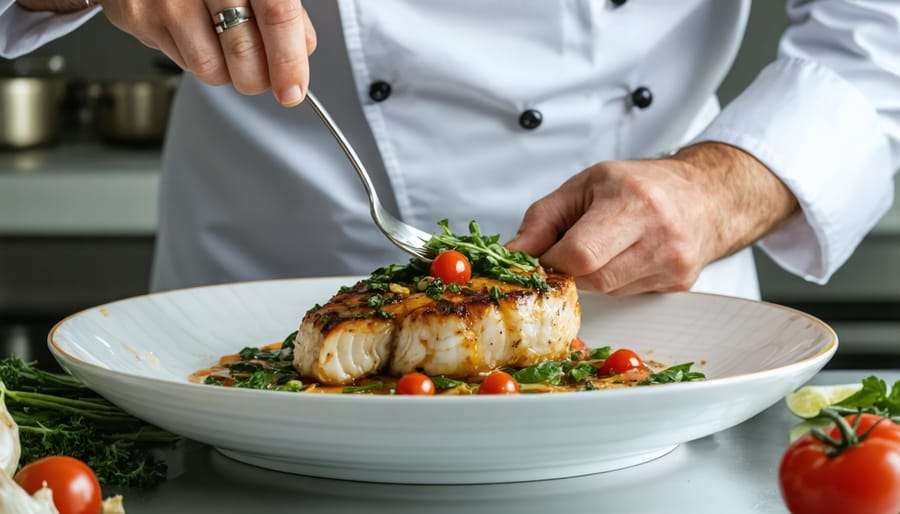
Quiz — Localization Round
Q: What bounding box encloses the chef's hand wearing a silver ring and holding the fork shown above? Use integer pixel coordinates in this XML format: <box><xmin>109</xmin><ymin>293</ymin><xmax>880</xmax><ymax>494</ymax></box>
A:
<box><xmin>102</xmin><ymin>0</ymin><xmax>316</xmax><ymax>107</ymax></box>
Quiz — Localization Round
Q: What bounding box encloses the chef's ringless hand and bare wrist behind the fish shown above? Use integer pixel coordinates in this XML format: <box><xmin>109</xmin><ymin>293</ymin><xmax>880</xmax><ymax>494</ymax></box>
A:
<box><xmin>507</xmin><ymin>143</ymin><xmax>799</xmax><ymax>295</ymax></box>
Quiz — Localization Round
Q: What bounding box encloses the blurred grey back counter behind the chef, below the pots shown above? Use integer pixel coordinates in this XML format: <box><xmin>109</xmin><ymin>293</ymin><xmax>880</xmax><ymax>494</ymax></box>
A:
<box><xmin>0</xmin><ymin>140</ymin><xmax>900</xmax><ymax>236</ymax></box>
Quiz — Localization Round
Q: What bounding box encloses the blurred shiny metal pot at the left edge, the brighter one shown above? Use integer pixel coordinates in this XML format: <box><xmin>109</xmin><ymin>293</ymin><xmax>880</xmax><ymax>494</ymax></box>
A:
<box><xmin>0</xmin><ymin>56</ymin><xmax>67</xmax><ymax>149</ymax></box>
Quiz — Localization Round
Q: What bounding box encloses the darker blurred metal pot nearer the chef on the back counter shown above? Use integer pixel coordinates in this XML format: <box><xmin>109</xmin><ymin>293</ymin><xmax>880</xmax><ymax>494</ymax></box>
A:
<box><xmin>94</xmin><ymin>76</ymin><xmax>179</xmax><ymax>145</ymax></box>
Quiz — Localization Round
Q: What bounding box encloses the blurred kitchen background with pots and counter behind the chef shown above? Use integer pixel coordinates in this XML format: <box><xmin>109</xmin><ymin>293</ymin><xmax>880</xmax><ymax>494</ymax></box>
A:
<box><xmin>0</xmin><ymin>1</ymin><xmax>900</xmax><ymax>368</ymax></box>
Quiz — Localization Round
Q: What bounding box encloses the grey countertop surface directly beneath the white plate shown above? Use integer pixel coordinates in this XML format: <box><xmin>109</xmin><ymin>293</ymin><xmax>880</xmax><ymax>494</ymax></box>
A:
<box><xmin>114</xmin><ymin>370</ymin><xmax>900</xmax><ymax>514</ymax></box>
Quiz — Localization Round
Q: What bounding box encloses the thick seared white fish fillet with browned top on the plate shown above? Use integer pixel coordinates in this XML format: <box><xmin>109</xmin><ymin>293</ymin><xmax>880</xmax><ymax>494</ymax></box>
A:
<box><xmin>293</xmin><ymin>273</ymin><xmax>581</xmax><ymax>385</ymax></box>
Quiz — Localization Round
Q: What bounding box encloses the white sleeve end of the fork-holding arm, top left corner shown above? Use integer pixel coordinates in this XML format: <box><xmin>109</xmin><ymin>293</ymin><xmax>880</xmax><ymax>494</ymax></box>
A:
<box><xmin>0</xmin><ymin>0</ymin><xmax>100</xmax><ymax>59</ymax></box>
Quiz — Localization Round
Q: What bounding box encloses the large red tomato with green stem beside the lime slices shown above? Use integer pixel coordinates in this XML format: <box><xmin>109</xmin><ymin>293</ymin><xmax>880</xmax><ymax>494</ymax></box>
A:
<box><xmin>778</xmin><ymin>414</ymin><xmax>900</xmax><ymax>514</ymax></box>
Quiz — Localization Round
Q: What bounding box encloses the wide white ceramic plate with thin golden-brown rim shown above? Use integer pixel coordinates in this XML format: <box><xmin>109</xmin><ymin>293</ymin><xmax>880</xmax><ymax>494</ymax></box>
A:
<box><xmin>49</xmin><ymin>277</ymin><xmax>837</xmax><ymax>484</ymax></box>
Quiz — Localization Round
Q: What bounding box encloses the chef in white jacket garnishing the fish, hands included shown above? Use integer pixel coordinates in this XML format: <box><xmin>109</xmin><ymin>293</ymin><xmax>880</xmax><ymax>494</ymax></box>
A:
<box><xmin>0</xmin><ymin>0</ymin><xmax>900</xmax><ymax>298</ymax></box>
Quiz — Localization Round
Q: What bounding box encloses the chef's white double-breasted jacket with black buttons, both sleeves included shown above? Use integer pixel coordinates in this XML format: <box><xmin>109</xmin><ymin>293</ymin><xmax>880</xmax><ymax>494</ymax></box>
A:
<box><xmin>0</xmin><ymin>0</ymin><xmax>900</xmax><ymax>297</ymax></box>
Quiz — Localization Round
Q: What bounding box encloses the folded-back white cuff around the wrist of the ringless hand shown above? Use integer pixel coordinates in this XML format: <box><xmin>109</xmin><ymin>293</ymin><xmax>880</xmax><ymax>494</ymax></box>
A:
<box><xmin>694</xmin><ymin>58</ymin><xmax>894</xmax><ymax>284</ymax></box>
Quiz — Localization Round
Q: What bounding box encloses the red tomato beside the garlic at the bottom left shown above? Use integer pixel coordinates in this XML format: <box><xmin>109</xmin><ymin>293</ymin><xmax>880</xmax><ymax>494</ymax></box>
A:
<box><xmin>16</xmin><ymin>456</ymin><xmax>103</xmax><ymax>514</ymax></box>
